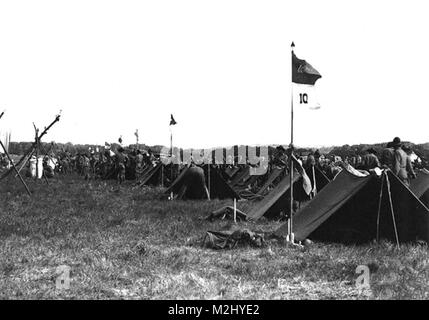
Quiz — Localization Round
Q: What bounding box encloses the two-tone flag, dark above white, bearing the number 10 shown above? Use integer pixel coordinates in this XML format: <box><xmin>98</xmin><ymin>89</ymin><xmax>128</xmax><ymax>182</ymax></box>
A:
<box><xmin>292</xmin><ymin>51</ymin><xmax>322</xmax><ymax>110</ymax></box>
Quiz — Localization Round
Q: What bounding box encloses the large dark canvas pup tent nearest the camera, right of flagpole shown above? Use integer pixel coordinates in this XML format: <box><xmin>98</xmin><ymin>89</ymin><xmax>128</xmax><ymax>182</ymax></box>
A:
<box><xmin>275</xmin><ymin>170</ymin><xmax>429</xmax><ymax>243</ymax></box>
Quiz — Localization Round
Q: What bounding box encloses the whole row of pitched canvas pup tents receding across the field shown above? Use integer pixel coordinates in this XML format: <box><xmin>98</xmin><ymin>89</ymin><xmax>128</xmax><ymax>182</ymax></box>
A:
<box><xmin>135</xmin><ymin>159</ymin><xmax>429</xmax><ymax>243</ymax></box>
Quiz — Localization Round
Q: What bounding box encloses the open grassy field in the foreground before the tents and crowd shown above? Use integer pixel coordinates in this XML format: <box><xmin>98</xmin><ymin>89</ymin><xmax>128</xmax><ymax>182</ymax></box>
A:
<box><xmin>0</xmin><ymin>176</ymin><xmax>429</xmax><ymax>299</ymax></box>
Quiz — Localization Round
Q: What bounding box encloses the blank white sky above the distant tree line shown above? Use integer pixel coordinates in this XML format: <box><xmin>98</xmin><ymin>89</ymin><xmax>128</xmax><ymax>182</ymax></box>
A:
<box><xmin>0</xmin><ymin>0</ymin><xmax>429</xmax><ymax>148</ymax></box>
